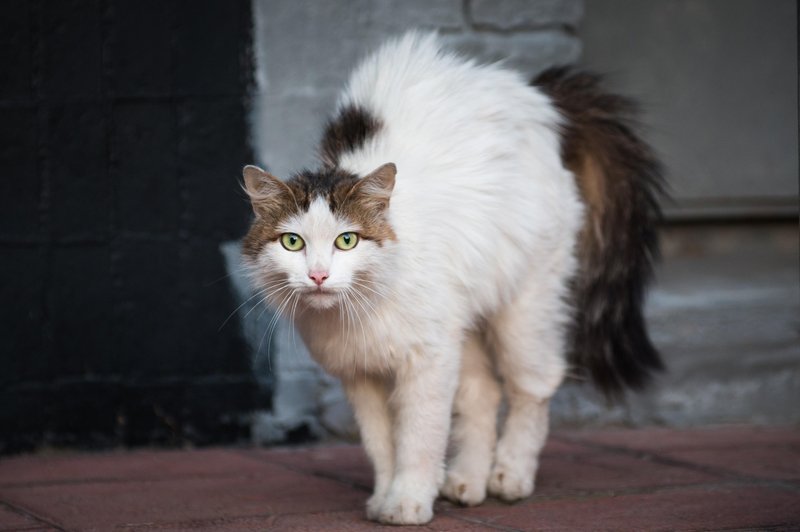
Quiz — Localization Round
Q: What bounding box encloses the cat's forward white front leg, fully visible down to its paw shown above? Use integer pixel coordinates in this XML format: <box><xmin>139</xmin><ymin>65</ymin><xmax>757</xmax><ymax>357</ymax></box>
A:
<box><xmin>378</xmin><ymin>349</ymin><xmax>458</xmax><ymax>525</ymax></box>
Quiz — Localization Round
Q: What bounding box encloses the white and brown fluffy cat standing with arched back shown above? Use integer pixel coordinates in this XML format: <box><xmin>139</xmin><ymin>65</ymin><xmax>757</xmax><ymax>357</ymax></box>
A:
<box><xmin>243</xmin><ymin>32</ymin><xmax>663</xmax><ymax>524</ymax></box>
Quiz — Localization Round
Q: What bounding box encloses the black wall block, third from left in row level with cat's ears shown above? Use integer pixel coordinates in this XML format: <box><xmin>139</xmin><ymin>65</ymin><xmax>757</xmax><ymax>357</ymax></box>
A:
<box><xmin>112</xmin><ymin>101</ymin><xmax>181</xmax><ymax>234</ymax></box>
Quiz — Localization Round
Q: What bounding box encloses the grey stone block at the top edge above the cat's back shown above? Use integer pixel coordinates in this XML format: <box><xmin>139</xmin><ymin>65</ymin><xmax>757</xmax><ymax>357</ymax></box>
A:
<box><xmin>468</xmin><ymin>0</ymin><xmax>583</xmax><ymax>31</ymax></box>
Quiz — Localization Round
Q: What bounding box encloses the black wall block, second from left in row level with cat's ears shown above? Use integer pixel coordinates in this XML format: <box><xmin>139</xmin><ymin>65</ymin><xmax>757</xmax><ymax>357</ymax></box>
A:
<box><xmin>47</xmin><ymin>103</ymin><xmax>112</xmax><ymax>240</ymax></box>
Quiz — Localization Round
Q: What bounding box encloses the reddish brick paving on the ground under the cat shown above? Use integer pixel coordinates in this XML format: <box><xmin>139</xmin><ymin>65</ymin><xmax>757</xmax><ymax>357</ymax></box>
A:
<box><xmin>0</xmin><ymin>427</ymin><xmax>800</xmax><ymax>531</ymax></box>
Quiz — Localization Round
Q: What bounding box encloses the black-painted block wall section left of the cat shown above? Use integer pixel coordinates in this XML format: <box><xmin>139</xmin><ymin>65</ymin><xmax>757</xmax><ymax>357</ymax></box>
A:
<box><xmin>0</xmin><ymin>0</ymin><xmax>266</xmax><ymax>452</ymax></box>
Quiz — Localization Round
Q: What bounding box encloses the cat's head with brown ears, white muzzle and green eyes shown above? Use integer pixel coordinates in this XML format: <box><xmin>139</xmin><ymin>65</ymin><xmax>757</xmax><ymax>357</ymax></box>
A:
<box><xmin>243</xmin><ymin>163</ymin><xmax>397</xmax><ymax>310</ymax></box>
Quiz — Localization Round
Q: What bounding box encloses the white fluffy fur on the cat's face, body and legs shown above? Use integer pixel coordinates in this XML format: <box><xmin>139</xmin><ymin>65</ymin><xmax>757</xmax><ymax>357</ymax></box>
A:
<box><xmin>250</xmin><ymin>33</ymin><xmax>582</xmax><ymax>523</ymax></box>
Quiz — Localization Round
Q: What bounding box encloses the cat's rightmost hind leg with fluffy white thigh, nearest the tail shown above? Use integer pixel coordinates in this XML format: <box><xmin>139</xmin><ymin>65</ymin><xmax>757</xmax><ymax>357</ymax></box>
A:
<box><xmin>488</xmin><ymin>269</ymin><xmax>569</xmax><ymax>501</ymax></box>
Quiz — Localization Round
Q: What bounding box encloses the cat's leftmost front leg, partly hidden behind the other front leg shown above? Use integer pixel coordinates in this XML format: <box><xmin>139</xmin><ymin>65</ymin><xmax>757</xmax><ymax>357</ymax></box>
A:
<box><xmin>342</xmin><ymin>376</ymin><xmax>394</xmax><ymax>520</ymax></box>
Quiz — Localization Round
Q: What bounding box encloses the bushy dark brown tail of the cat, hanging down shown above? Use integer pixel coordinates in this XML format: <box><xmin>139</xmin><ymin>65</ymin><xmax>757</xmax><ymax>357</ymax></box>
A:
<box><xmin>532</xmin><ymin>68</ymin><xmax>664</xmax><ymax>397</ymax></box>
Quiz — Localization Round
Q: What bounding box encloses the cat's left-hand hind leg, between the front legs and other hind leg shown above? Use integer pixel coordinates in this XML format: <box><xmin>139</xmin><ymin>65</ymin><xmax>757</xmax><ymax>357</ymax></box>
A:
<box><xmin>441</xmin><ymin>333</ymin><xmax>501</xmax><ymax>506</ymax></box>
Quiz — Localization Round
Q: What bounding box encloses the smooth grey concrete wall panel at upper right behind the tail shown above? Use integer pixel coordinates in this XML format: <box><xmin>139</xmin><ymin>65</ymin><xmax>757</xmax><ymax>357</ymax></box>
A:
<box><xmin>578</xmin><ymin>0</ymin><xmax>798</xmax><ymax>218</ymax></box>
